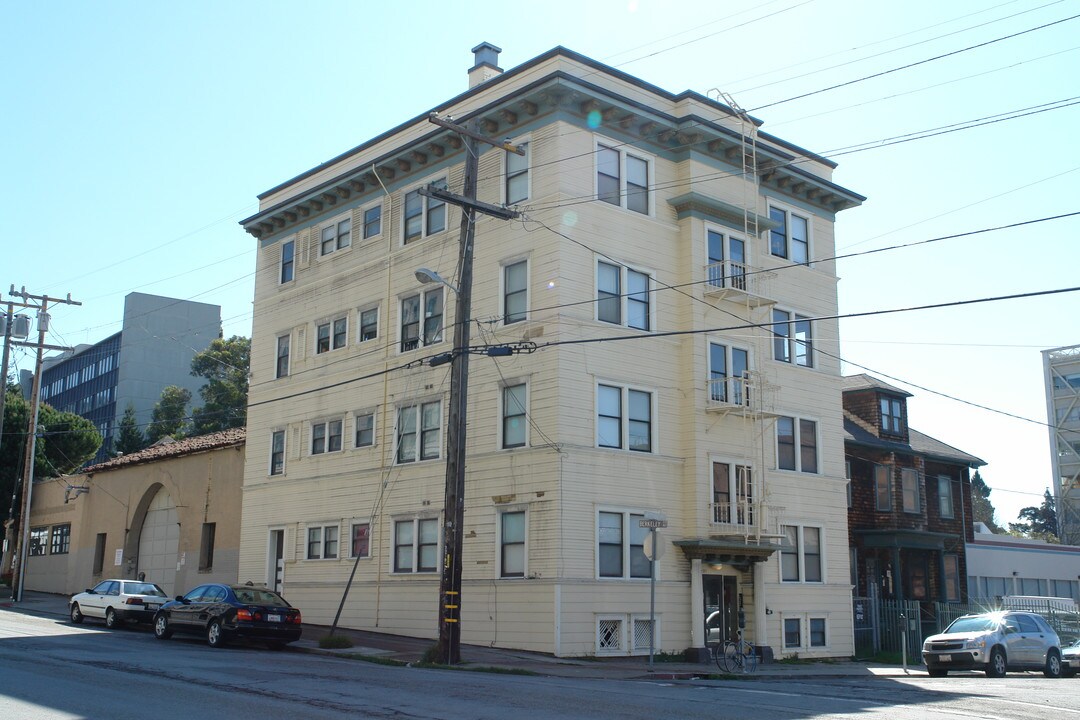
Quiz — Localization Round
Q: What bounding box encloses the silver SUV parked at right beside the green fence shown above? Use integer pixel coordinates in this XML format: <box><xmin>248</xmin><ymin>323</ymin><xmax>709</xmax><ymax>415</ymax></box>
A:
<box><xmin>922</xmin><ymin>611</ymin><xmax>1062</xmax><ymax>678</ymax></box>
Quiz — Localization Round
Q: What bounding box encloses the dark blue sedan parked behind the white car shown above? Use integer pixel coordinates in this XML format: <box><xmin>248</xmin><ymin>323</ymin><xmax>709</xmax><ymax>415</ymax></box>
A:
<box><xmin>153</xmin><ymin>583</ymin><xmax>302</xmax><ymax>649</ymax></box>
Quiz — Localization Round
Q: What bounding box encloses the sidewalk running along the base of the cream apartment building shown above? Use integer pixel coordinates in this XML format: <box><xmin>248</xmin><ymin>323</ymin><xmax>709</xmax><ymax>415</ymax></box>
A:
<box><xmin>0</xmin><ymin>588</ymin><xmax>926</xmax><ymax>680</ymax></box>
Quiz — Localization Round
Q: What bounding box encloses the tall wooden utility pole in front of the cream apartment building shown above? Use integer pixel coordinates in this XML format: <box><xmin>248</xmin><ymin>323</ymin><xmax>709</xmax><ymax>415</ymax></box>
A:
<box><xmin>420</xmin><ymin>113</ymin><xmax>525</xmax><ymax>665</ymax></box>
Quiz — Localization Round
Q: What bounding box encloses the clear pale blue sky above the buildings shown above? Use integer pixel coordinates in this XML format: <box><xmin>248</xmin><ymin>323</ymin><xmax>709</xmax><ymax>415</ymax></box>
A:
<box><xmin>0</xmin><ymin>0</ymin><xmax>1080</xmax><ymax>521</ymax></box>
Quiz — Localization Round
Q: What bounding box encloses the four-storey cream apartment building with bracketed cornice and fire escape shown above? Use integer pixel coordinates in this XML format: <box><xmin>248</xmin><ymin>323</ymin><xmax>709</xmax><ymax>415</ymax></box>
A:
<box><xmin>240</xmin><ymin>43</ymin><xmax>864</xmax><ymax>656</ymax></box>
